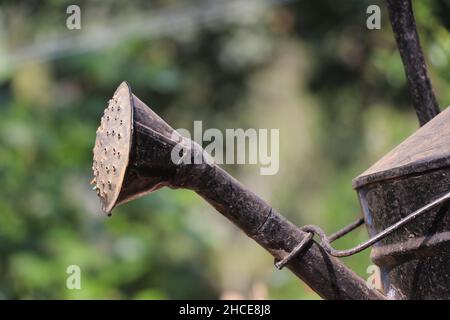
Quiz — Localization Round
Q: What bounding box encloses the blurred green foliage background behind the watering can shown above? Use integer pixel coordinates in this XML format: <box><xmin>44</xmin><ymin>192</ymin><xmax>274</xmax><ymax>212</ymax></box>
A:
<box><xmin>0</xmin><ymin>0</ymin><xmax>450</xmax><ymax>299</ymax></box>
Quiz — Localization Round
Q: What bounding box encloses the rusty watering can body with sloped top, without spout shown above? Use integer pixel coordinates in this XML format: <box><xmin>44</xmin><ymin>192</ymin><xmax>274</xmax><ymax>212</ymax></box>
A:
<box><xmin>353</xmin><ymin>108</ymin><xmax>450</xmax><ymax>299</ymax></box>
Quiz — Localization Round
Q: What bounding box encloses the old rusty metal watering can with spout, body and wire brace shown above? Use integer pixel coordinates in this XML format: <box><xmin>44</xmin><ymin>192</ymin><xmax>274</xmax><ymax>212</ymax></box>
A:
<box><xmin>92</xmin><ymin>82</ymin><xmax>450</xmax><ymax>299</ymax></box>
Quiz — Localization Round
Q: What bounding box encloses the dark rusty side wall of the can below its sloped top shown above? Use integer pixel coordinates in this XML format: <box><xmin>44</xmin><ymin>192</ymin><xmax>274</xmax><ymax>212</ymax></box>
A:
<box><xmin>358</xmin><ymin>167</ymin><xmax>450</xmax><ymax>299</ymax></box>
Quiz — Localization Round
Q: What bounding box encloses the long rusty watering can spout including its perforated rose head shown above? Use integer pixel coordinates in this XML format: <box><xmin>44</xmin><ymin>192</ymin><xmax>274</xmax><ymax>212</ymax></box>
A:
<box><xmin>93</xmin><ymin>82</ymin><xmax>384</xmax><ymax>299</ymax></box>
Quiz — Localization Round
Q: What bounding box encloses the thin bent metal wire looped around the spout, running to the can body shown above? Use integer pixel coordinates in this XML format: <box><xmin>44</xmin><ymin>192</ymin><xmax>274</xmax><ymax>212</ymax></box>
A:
<box><xmin>275</xmin><ymin>192</ymin><xmax>450</xmax><ymax>269</ymax></box>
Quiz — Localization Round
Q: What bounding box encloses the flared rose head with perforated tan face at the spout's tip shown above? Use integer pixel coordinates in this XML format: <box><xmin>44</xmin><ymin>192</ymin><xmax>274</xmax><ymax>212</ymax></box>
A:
<box><xmin>92</xmin><ymin>82</ymin><xmax>201</xmax><ymax>214</ymax></box>
